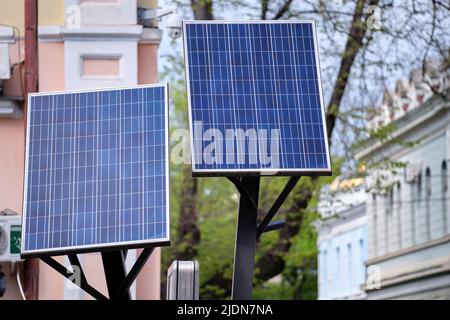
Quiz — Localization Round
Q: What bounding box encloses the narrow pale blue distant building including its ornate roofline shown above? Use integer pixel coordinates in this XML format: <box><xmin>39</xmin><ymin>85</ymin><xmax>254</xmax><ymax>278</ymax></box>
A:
<box><xmin>316</xmin><ymin>179</ymin><xmax>367</xmax><ymax>300</ymax></box>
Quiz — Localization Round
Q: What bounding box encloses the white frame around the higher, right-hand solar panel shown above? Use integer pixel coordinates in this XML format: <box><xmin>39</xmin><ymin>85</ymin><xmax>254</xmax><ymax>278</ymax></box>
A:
<box><xmin>183</xmin><ymin>20</ymin><xmax>331</xmax><ymax>176</ymax></box>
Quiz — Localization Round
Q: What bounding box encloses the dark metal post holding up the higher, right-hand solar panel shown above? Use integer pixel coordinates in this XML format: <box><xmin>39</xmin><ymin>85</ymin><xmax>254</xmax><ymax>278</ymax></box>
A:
<box><xmin>231</xmin><ymin>177</ymin><xmax>260</xmax><ymax>300</ymax></box>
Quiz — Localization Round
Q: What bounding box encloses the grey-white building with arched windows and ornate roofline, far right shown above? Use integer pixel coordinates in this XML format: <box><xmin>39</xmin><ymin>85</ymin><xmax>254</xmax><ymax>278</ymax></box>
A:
<box><xmin>357</xmin><ymin>63</ymin><xmax>450</xmax><ymax>299</ymax></box>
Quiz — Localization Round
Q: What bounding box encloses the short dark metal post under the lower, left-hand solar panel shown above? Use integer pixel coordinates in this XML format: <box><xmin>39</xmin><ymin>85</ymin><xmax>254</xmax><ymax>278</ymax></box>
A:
<box><xmin>102</xmin><ymin>251</ymin><xmax>131</xmax><ymax>300</ymax></box>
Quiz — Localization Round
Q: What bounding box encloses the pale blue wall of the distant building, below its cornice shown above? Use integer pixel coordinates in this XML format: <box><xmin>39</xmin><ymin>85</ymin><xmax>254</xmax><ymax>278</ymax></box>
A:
<box><xmin>318</xmin><ymin>224</ymin><xmax>367</xmax><ymax>300</ymax></box>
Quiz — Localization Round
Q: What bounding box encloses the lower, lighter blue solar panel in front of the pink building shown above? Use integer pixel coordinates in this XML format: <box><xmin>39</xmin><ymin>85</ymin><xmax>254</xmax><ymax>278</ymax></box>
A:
<box><xmin>22</xmin><ymin>84</ymin><xmax>169</xmax><ymax>256</ymax></box>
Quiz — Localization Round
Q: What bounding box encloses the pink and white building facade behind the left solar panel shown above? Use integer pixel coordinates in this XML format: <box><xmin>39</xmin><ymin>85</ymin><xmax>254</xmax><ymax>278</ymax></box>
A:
<box><xmin>0</xmin><ymin>0</ymin><xmax>162</xmax><ymax>299</ymax></box>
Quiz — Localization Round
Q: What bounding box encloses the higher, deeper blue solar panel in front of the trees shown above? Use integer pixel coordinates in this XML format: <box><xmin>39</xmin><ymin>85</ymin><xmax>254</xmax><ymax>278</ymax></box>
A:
<box><xmin>183</xmin><ymin>21</ymin><xmax>331</xmax><ymax>175</ymax></box>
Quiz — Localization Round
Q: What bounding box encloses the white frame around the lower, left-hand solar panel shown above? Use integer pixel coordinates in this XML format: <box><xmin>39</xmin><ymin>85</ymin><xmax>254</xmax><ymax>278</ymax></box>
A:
<box><xmin>20</xmin><ymin>82</ymin><xmax>170</xmax><ymax>256</ymax></box>
